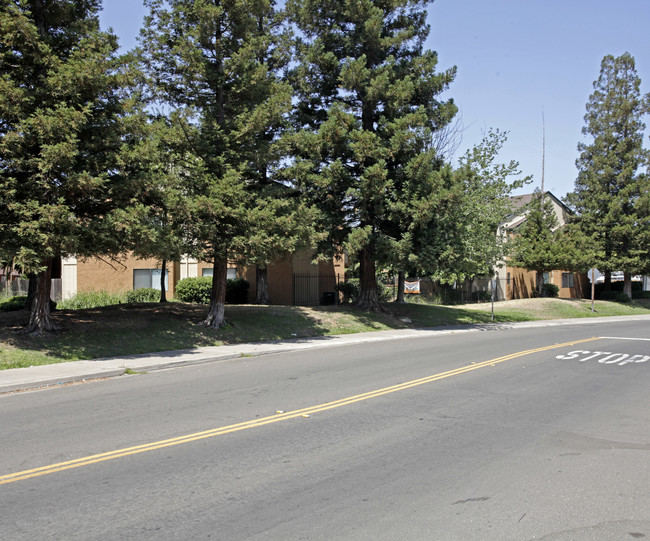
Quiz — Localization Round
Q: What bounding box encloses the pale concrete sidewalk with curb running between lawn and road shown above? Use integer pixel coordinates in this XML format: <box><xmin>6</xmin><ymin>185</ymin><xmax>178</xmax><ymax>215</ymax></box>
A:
<box><xmin>0</xmin><ymin>316</ymin><xmax>650</xmax><ymax>394</ymax></box>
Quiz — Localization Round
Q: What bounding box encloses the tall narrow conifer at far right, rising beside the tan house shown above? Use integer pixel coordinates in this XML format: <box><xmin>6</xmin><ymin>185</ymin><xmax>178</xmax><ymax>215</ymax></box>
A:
<box><xmin>567</xmin><ymin>53</ymin><xmax>650</xmax><ymax>296</ymax></box>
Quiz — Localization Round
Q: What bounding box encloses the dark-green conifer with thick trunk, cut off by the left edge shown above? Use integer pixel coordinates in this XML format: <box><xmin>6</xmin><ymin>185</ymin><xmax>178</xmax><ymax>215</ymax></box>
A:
<box><xmin>0</xmin><ymin>0</ymin><xmax>126</xmax><ymax>333</ymax></box>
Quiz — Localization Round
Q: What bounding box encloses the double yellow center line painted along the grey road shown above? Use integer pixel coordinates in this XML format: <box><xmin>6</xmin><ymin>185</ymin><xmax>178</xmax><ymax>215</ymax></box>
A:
<box><xmin>0</xmin><ymin>337</ymin><xmax>599</xmax><ymax>485</ymax></box>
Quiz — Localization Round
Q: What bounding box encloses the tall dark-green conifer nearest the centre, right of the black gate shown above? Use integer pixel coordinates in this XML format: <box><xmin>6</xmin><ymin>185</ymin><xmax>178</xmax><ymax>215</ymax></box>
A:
<box><xmin>287</xmin><ymin>0</ymin><xmax>456</xmax><ymax>310</ymax></box>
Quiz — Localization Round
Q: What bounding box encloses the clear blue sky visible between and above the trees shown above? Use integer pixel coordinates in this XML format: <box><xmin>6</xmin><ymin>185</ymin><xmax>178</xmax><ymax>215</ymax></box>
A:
<box><xmin>96</xmin><ymin>0</ymin><xmax>650</xmax><ymax>197</ymax></box>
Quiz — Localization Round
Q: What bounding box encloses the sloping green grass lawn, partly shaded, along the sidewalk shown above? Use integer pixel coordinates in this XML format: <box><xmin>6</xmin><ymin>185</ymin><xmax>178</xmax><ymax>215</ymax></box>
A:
<box><xmin>0</xmin><ymin>299</ymin><xmax>650</xmax><ymax>369</ymax></box>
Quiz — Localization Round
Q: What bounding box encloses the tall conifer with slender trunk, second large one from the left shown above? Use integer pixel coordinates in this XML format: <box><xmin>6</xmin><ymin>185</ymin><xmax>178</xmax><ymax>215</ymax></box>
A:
<box><xmin>141</xmin><ymin>0</ymin><xmax>304</xmax><ymax>328</ymax></box>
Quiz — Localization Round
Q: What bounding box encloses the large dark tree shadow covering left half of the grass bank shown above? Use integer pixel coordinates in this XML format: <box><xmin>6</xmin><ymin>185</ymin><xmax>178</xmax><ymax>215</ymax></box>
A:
<box><xmin>0</xmin><ymin>303</ymin><xmax>380</xmax><ymax>368</ymax></box>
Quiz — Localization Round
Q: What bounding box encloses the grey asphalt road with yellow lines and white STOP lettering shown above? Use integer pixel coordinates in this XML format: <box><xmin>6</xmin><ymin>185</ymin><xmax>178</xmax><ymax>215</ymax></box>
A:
<box><xmin>0</xmin><ymin>322</ymin><xmax>650</xmax><ymax>541</ymax></box>
